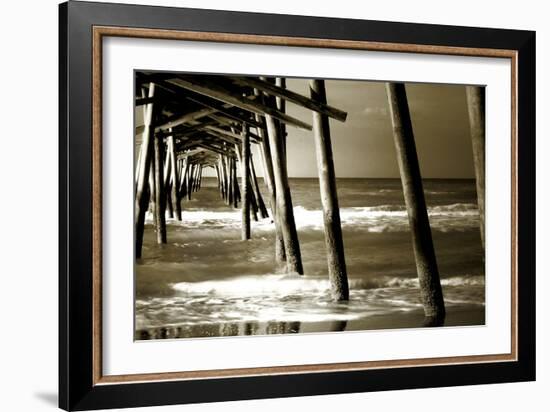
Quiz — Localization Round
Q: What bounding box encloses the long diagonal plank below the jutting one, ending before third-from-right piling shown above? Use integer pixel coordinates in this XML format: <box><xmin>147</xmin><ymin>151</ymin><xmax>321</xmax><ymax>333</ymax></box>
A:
<box><xmin>167</xmin><ymin>76</ymin><xmax>312</xmax><ymax>130</ymax></box>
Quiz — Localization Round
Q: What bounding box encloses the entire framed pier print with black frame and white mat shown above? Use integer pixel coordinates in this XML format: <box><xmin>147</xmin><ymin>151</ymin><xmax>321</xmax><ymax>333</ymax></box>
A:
<box><xmin>59</xmin><ymin>1</ymin><xmax>535</xmax><ymax>410</ymax></box>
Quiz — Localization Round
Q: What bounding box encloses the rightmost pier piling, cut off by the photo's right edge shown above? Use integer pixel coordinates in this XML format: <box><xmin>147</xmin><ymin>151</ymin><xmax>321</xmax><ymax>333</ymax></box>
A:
<box><xmin>466</xmin><ymin>86</ymin><xmax>485</xmax><ymax>249</ymax></box>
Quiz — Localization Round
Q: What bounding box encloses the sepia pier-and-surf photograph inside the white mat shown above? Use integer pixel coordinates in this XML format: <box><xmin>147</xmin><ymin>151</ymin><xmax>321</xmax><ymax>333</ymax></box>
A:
<box><xmin>135</xmin><ymin>69</ymin><xmax>486</xmax><ymax>340</ymax></box>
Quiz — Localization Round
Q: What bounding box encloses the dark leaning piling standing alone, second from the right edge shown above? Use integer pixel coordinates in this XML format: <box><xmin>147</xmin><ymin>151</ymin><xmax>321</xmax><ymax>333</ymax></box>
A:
<box><xmin>386</xmin><ymin>83</ymin><xmax>445</xmax><ymax>326</ymax></box>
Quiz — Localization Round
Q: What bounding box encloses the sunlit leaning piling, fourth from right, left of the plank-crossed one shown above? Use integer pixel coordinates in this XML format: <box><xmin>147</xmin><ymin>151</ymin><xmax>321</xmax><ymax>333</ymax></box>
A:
<box><xmin>266</xmin><ymin>115</ymin><xmax>304</xmax><ymax>275</ymax></box>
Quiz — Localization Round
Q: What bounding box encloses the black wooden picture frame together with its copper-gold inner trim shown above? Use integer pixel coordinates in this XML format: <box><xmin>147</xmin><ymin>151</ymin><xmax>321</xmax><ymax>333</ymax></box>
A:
<box><xmin>59</xmin><ymin>1</ymin><xmax>535</xmax><ymax>410</ymax></box>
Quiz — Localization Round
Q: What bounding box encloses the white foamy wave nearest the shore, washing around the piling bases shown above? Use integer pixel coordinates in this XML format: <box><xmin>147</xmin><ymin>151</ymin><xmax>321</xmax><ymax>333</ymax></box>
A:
<box><xmin>136</xmin><ymin>274</ymin><xmax>484</xmax><ymax>329</ymax></box>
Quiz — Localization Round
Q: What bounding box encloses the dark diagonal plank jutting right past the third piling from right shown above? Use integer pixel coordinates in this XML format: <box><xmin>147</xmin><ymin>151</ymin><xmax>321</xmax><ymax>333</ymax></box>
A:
<box><xmin>231</xmin><ymin>76</ymin><xmax>348</xmax><ymax>122</ymax></box>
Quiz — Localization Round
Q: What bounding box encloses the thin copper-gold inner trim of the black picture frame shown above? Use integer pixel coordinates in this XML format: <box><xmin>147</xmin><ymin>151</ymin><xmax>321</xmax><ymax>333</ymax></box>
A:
<box><xmin>92</xmin><ymin>26</ymin><xmax>518</xmax><ymax>385</ymax></box>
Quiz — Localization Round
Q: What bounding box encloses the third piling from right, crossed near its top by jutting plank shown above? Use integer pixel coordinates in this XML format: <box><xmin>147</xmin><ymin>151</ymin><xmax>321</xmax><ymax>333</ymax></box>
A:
<box><xmin>309</xmin><ymin>80</ymin><xmax>349</xmax><ymax>301</ymax></box>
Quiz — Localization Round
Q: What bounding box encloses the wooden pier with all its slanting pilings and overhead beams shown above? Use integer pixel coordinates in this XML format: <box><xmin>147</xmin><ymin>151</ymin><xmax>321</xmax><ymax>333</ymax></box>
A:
<box><xmin>135</xmin><ymin>71</ymin><xmax>462</xmax><ymax>326</ymax></box>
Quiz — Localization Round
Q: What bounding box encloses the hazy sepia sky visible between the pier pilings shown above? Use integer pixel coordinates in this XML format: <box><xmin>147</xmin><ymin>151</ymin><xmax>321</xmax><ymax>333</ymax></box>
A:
<box><xmin>136</xmin><ymin>79</ymin><xmax>474</xmax><ymax>178</ymax></box>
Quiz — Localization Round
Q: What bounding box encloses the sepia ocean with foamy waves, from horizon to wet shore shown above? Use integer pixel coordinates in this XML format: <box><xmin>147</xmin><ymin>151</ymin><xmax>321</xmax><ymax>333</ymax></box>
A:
<box><xmin>135</xmin><ymin>178</ymin><xmax>485</xmax><ymax>340</ymax></box>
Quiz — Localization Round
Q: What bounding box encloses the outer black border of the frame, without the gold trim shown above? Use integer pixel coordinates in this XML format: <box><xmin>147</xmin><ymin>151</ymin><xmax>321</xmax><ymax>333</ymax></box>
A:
<box><xmin>59</xmin><ymin>1</ymin><xmax>536</xmax><ymax>410</ymax></box>
